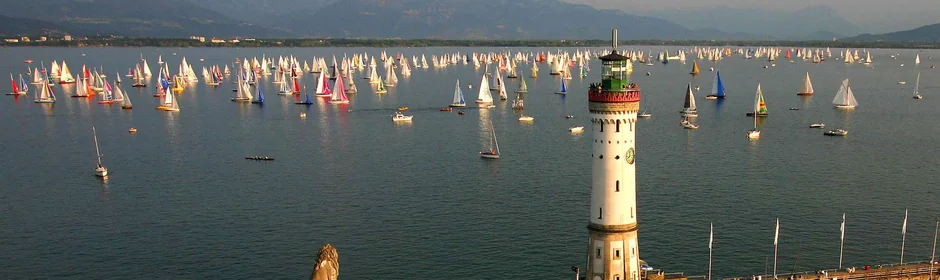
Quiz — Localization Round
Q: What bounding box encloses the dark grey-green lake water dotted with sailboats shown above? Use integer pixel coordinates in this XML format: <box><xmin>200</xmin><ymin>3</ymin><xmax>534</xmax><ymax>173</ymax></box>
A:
<box><xmin>0</xmin><ymin>46</ymin><xmax>940</xmax><ymax>279</ymax></box>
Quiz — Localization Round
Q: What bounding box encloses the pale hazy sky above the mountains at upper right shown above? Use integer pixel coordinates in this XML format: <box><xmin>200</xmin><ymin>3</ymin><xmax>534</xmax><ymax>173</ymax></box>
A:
<box><xmin>562</xmin><ymin>0</ymin><xmax>940</xmax><ymax>32</ymax></box>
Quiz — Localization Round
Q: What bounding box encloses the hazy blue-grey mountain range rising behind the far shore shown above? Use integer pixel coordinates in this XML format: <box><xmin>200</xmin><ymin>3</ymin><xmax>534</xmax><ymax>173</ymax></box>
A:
<box><xmin>0</xmin><ymin>0</ymin><xmax>940</xmax><ymax>41</ymax></box>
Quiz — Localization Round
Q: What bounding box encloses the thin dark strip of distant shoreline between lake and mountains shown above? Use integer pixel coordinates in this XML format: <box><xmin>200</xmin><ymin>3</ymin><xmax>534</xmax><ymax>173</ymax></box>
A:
<box><xmin>0</xmin><ymin>38</ymin><xmax>940</xmax><ymax>49</ymax></box>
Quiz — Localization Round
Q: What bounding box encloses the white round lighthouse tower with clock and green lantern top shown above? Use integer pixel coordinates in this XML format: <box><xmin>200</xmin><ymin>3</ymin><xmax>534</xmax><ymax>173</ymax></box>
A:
<box><xmin>586</xmin><ymin>29</ymin><xmax>640</xmax><ymax>280</ymax></box>
